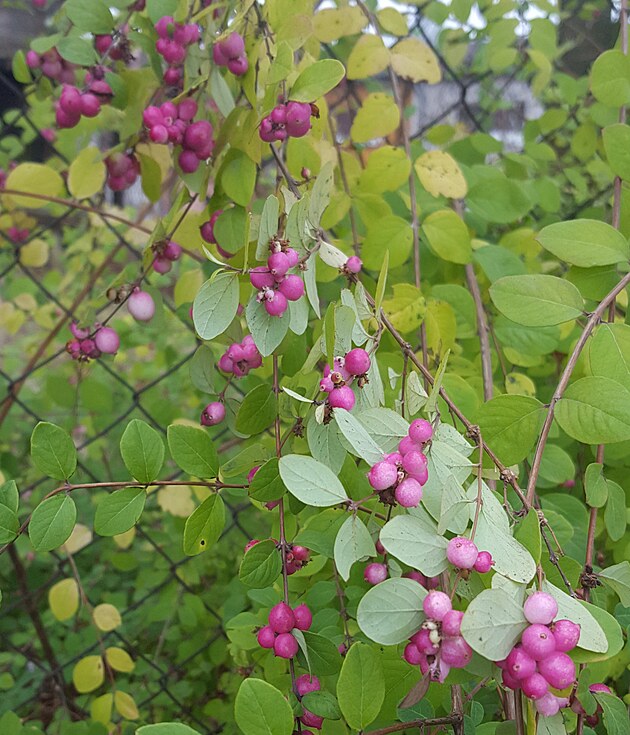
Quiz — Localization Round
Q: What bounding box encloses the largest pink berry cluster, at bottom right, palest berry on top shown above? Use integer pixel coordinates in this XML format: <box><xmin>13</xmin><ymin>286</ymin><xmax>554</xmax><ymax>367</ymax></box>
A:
<box><xmin>497</xmin><ymin>592</ymin><xmax>580</xmax><ymax>717</ymax></box>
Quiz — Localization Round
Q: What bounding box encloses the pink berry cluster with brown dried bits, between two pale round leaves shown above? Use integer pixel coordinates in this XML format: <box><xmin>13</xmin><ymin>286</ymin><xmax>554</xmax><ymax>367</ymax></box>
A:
<box><xmin>403</xmin><ymin>590</ymin><xmax>472</xmax><ymax>682</ymax></box>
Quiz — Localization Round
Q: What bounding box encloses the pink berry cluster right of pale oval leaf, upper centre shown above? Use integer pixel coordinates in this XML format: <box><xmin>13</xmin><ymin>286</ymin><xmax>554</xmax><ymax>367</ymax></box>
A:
<box><xmin>249</xmin><ymin>239</ymin><xmax>304</xmax><ymax>316</ymax></box>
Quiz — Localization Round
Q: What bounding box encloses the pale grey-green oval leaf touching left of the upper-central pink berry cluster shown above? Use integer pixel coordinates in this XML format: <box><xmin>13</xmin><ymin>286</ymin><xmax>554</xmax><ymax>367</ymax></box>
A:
<box><xmin>193</xmin><ymin>270</ymin><xmax>239</xmax><ymax>340</ymax></box>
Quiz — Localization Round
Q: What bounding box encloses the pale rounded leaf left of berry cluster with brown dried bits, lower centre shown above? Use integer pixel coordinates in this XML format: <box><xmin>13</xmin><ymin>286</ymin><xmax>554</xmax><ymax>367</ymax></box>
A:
<box><xmin>357</xmin><ymin>576</ymin><xmax>427</xmax><ymax>646</ymax></box>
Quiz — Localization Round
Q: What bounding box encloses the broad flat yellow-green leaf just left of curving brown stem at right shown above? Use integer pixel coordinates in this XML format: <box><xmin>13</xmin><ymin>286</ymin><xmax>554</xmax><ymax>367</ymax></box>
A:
<box><xmin>476</xmin><ymin>395</ymin><xmax>545</xmax><ymax>466</ymax></box>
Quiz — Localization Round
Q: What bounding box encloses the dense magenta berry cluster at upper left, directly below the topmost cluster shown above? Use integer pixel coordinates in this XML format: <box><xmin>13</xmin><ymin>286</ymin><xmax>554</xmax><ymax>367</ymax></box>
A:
<box><xmin>142</xmin><ymin>97</ymin><xmax>214</xmax><ymax>174</ymax></box>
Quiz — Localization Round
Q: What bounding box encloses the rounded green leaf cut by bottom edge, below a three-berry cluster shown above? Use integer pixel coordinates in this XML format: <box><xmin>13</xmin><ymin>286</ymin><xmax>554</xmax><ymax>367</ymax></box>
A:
<box><xmin>234</xmin><ymin>678</ymin><xmax>293</xmax><ymax>735</ymax></box>
